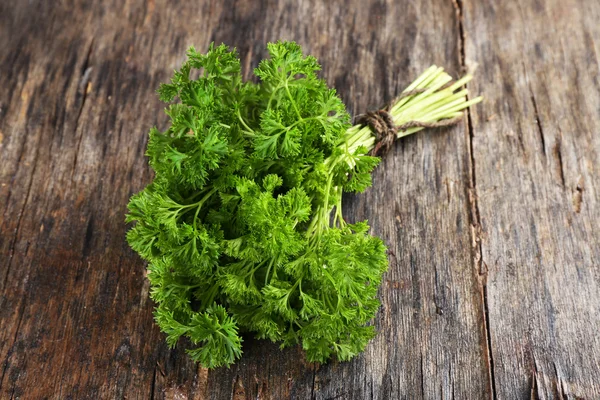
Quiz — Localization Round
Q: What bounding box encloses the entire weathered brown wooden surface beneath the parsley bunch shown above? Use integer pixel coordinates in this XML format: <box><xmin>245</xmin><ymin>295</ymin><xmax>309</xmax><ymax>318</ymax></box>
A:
<box><xmin>0</xmin><ymin>0</ymin><xmax>600</xmax><ymax>400</ymax></box>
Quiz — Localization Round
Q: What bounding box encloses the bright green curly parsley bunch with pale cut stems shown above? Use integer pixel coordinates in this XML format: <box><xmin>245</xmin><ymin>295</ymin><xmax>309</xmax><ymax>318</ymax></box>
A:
<box><xmin>126</xmin><ymin>42</ymin><xmax>478</xmax><ymax>368</ymax></box>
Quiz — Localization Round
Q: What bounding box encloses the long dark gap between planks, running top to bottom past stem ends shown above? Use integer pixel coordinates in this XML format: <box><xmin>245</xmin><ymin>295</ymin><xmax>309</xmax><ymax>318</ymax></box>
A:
<box><xmin>452</xmin><ymin>0</ymin><xmax>497</xmax><ymax>399</ymax></box>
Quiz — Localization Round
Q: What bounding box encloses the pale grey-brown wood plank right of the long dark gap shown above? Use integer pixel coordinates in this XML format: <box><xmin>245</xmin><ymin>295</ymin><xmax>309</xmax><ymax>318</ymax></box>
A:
<box><xmin>463</xmin><ymin>0</ymin><xmax>600</xmax><ymax>399</ymax></box>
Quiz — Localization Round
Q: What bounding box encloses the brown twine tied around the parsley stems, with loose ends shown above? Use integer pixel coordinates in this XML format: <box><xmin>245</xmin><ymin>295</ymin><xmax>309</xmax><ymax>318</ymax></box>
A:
<box><xmin>354</xmin><ymin>85</ymin><xmax>462</xmax><ymax>156</ymax></box>
